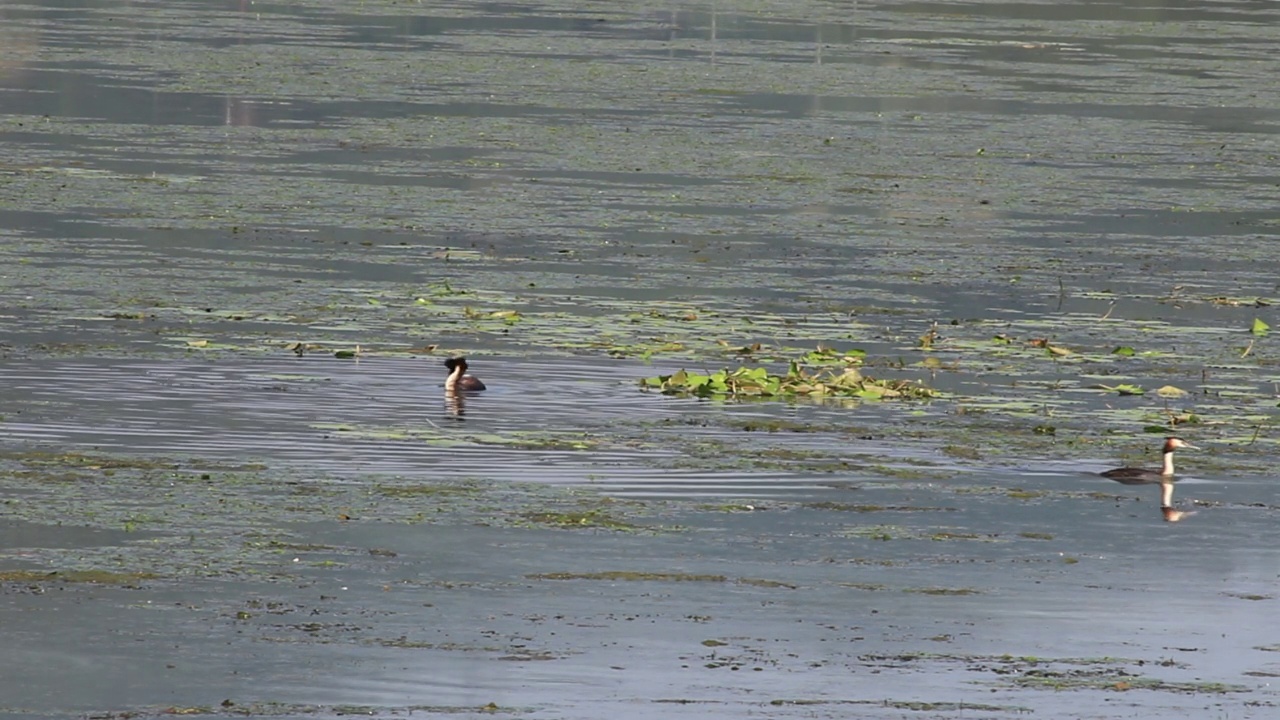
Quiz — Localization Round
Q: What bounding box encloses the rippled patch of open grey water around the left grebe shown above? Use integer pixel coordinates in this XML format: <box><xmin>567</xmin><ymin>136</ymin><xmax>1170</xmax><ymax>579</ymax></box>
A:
<box><xmin>0</xmin><ymin>356</ymin><xmax>829</xmax><ymax>495</ymax></box>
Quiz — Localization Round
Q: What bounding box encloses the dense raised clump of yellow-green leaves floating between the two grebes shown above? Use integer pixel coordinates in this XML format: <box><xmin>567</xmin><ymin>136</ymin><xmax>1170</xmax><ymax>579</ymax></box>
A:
<box><xmin>640</xmin><ymin>356</ymin><xmax>938</xmax><ymax>400</ymax></box>
